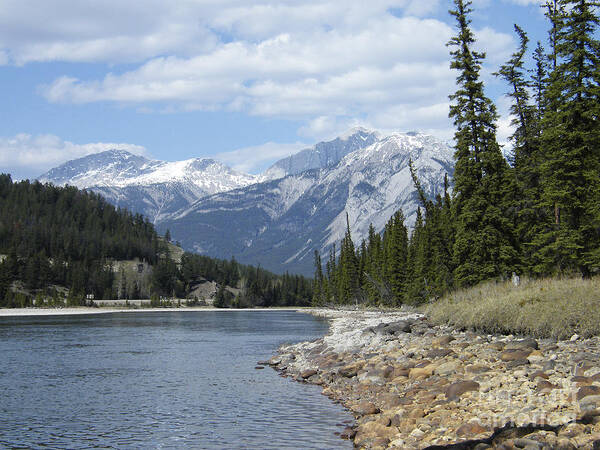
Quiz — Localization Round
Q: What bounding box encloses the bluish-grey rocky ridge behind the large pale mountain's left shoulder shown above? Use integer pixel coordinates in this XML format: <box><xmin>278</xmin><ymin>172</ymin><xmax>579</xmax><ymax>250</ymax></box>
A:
<box><xmin>263</xmin><ymin>127</ymin><xmax>382</xmax><ymax>180</ymax></box>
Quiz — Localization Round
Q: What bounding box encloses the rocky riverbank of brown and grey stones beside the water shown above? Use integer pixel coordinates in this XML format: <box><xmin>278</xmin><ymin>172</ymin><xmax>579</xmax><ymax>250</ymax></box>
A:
<box><xmin>263</xmin><ymin>310</ymin><xmax>600</xmax><ymax>450</ymax></box>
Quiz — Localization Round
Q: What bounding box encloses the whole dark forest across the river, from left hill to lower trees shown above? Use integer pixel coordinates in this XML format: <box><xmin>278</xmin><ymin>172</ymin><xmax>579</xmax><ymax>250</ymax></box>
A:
<box><xmin>0</xmin><ymin>174</ymin><xmax>312</xmax><ymax>307</ymax></box>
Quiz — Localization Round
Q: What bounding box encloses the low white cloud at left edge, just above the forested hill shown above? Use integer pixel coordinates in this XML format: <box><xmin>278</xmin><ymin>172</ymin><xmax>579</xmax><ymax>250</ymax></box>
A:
<box><xmin>0</xmin><ymin>133</ymin><xmax>146</xmax><ymax>178</ymax></box>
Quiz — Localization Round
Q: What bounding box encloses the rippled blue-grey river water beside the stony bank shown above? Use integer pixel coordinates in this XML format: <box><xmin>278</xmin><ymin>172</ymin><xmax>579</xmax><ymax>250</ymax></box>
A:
<box><xmin>0</xmin><ymin>311</ymin><xmax>352</xmax><ymax>449</ymax></box>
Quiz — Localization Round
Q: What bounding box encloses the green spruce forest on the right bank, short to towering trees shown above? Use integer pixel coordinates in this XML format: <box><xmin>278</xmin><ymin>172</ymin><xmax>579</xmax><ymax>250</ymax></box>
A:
<box><xmin>313</xmin><ymin>0</ymin><xmax>600</xmax><ymax>306</ymax></box>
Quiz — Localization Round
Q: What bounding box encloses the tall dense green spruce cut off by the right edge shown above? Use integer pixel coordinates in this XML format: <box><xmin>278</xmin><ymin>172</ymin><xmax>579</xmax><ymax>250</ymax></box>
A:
<box><xmin>534</xmin><ymin>0</ymin><xmax>600</xmax><ymax>275</ymax></box>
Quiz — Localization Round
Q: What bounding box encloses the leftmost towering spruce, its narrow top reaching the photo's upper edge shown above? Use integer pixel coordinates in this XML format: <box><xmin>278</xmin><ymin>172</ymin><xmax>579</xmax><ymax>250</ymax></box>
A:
<box><xmin>448</xmin><ymin>0</ymin><xmax>517</xmax><ymax>286</ymax></box>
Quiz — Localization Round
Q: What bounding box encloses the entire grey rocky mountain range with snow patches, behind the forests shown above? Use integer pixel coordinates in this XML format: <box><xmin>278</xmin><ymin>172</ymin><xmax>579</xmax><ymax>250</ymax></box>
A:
<box><xmin>39</xmin><ymin>128</ymin><xmax>453</xmax><ymax>275</ymax></box>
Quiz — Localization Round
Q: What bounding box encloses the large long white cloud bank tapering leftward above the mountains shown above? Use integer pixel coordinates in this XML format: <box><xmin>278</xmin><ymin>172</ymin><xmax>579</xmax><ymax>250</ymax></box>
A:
<box><xmin>37</xmin><ymin>13</ymin><xmax>478</xmax><ymax>138</ymax></box>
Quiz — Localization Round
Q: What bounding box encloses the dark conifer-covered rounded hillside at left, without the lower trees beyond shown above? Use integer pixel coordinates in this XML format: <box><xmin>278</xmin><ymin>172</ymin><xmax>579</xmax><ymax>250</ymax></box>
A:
<box><xmin>0</xmin><ymin>174</ymin><xmax>160</xmax><ymax>306</ymax></box>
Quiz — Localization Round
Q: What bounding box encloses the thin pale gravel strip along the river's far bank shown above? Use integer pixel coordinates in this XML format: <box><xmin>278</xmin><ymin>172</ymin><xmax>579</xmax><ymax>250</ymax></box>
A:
<box><xmin>0</xmin><ymin>306</ymin><xmax>310</xmax><ymax>318</ymax></box>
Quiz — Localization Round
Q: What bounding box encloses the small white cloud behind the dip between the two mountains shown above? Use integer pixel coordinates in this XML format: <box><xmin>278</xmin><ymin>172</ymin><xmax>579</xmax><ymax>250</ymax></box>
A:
<box><xmin>214</xmin><ymin>142</ymin><xmax>308</xmax><ymax>173</ymax></box>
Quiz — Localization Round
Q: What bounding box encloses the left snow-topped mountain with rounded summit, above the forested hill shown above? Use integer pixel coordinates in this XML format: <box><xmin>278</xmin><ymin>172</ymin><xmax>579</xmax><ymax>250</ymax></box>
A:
<box><xmin>38</xmin><ymin>150</ymin><xmax>257</xmax><ymax>223</ymax></box>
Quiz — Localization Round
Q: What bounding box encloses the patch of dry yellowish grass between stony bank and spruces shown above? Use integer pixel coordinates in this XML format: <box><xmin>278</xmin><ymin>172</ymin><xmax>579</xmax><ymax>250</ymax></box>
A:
<box><xmin>424</xmin><ymin>277</ymin><xmax>600</xmax><ymax>339</ymax></box>
